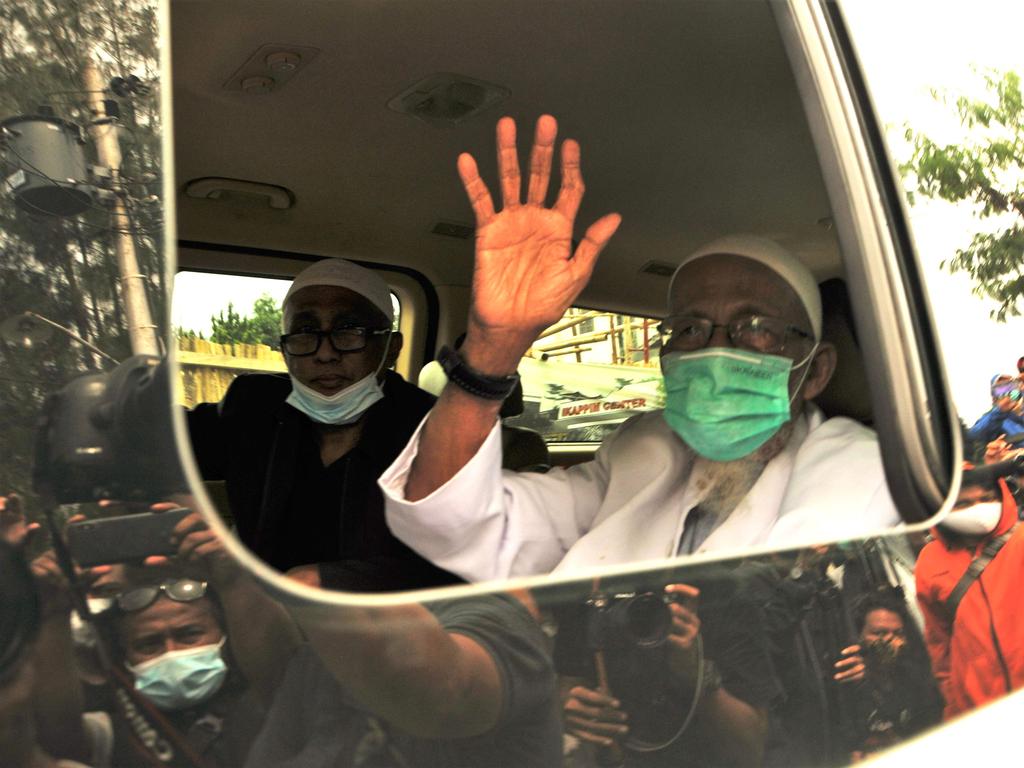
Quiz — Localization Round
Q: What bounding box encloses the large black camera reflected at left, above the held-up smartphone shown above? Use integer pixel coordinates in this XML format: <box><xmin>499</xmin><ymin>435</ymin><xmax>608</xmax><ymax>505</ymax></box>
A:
<box><xmin>33</xmin><ymin>354</ymin><xmax>187</xmax><ymax>504</ymax></box>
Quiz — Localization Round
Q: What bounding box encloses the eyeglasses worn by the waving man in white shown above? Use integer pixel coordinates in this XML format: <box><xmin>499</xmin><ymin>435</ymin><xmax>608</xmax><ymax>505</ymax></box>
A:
<box><xmin>657</xmin><ymin>314</ymin><xmax>812</xmax><ymax>354</ymax></box>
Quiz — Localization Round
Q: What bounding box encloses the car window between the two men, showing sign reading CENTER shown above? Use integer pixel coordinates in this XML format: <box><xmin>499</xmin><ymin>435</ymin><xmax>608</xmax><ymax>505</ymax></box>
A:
<box><xmin>506</xmin><ymin>308</ymin><xmax>665</xmax><ymax>442</ymax></box>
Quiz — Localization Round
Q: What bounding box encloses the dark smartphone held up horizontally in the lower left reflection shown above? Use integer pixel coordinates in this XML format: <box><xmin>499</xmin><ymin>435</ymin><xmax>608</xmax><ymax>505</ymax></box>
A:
<box><xmin>68</xmin><ymin>507</ymin><xmax>191</xmax><ymax>567</ymax></box>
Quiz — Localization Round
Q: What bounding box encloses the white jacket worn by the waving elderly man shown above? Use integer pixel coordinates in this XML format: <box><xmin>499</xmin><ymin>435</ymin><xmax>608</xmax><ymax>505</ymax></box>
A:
<box><xmin>379</xmin><ymin>406</ymin><xmax>899</xmax><ymax>582</ymax></box>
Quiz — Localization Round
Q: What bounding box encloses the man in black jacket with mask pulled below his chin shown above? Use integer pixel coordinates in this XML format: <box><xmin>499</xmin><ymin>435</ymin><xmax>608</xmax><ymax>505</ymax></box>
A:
<box><xmin>188</xmin><ymin>259</ymin><xmax>456</xmax><ymax>592</ymax></box>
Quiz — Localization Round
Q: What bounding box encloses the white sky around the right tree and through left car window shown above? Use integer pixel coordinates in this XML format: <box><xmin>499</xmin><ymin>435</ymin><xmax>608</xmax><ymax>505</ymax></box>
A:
<box><xmin>172</xmin><ymin>0</ymin><xmax>1024</xmax><ymax>424</ymax></box>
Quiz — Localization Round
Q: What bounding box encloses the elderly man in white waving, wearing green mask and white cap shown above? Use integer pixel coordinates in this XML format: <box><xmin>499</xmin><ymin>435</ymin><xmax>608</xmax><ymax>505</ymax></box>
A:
<box><xmin>380</xmin><ymin>116</ymin><xmax>899</xmax><ymax>581</ymax></box>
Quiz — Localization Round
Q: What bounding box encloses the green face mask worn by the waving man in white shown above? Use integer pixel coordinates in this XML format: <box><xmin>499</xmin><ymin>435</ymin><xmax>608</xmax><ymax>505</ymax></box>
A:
<box><xmin>662</xmin><ymin>345</ymin><xmax>817</xmax><ymax>462</ymax></box>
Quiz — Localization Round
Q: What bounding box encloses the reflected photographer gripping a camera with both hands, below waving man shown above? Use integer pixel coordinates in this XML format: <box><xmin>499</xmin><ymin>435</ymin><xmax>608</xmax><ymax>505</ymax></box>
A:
<box><xmin>555</xmin><ymin>570</ymin><xmax>779</xmax><ymax>766</ymax></box>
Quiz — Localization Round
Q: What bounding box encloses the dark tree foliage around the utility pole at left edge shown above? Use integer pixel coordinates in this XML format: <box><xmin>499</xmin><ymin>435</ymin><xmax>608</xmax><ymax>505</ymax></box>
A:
<box><xmin>0</xmin><ymin>0</ymin><xmax>164</xmax><ymax>519</ymax></box>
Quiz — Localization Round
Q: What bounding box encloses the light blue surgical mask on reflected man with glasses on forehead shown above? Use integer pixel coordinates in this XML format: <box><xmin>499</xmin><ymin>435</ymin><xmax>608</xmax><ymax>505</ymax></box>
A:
<box><xmin>127</xmin><ymin>638</ymin><xmax>227</xmax><ymax>710</ymax></box>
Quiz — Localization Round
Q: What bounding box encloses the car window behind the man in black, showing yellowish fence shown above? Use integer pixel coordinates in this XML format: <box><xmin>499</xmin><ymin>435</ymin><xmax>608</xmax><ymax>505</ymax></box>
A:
<box><xmin>171</xmin><ymin>271</ymin><xmax>401</xmax><ymax>408</ymax></box>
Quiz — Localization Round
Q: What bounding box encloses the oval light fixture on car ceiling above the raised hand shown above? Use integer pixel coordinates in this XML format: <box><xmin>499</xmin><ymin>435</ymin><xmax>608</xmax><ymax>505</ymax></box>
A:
<box><xmin>387</xmin><ymin>72</ymin><xmax>511</xmax><ymax>126</ymax></box>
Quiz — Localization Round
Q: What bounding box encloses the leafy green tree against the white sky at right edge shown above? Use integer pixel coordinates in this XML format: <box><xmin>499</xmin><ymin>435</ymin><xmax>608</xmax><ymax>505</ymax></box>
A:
<box><xmin>901</xmin><ymin>72</ymin><xmax>1024</xmax><ymax>322</ymax></box>
